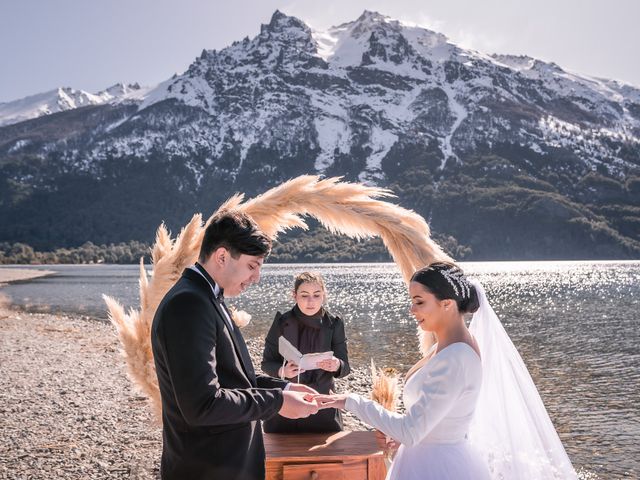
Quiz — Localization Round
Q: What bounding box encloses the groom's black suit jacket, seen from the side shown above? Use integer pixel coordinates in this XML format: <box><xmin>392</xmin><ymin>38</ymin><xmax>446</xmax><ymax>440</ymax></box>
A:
<box><xmin>151</xmin><ymin>269</ymin><xmax>287</xmax><ymax>480</ymax></box>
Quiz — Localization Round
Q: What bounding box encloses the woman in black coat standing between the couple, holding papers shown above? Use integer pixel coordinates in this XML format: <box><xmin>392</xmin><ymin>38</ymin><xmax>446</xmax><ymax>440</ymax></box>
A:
<box><xmin>262</xmin><ymin>272</ymin><xmax>350</xmax><ymax>433</ymax></box>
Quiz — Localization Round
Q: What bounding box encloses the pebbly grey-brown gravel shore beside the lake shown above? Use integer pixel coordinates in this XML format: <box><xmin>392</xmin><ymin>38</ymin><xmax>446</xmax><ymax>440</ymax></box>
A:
<box><xmin>0</xmin><ymin>303</ymin><xmax>392</xmax><ymax>480</ymax></box>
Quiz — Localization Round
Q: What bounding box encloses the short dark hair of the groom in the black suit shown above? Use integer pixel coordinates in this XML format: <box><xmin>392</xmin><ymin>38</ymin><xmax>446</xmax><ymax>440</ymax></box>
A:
<box><xmin>198</xmin><ymin>210</ymin><xmax>271</xmax><ymax>263</ymax></box>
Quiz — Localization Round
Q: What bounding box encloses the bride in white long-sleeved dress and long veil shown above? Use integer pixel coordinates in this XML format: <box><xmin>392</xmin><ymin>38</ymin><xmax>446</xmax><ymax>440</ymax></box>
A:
<box><xmin>316</xmin><ymin>263</ymin><xmax>577</xmax><ymax>480</ymax></box>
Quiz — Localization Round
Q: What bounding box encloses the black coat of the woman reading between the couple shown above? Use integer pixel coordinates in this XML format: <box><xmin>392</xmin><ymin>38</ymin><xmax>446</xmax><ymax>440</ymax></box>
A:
<box><xmin>262</xmin><ymin>310</ymin><xmax>351</xmax><ymax>433</ymax></box>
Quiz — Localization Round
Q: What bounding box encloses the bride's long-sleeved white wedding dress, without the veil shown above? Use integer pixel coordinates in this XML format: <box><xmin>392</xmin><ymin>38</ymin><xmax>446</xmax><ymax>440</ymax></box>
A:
<box><xmin>346</xmin><ymin>342</ymin><xmax>490</xmax><ymax>480</ymax></box>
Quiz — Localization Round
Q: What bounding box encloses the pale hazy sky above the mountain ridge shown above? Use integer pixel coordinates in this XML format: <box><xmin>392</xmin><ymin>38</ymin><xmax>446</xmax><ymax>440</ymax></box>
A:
<box><xmin>0</xmin><ymin>0</ymin><xmax>640</xmax><ymax>102</ymax></box>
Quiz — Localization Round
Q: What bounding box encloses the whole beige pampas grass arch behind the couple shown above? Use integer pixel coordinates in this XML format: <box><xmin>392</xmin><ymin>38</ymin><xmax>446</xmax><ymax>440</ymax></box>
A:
<box><xmin>104</xmin><ymin>175</ymin><xmax>451</xmax><ymax>418</ymax></box>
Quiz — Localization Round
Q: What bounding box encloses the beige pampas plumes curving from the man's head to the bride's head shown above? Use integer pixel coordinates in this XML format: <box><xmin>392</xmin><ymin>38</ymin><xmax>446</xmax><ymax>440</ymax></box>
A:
<box><xmin>232</xmin><ymin>175</ymin><xmax>451</xmax><ymax>282</ymax></box>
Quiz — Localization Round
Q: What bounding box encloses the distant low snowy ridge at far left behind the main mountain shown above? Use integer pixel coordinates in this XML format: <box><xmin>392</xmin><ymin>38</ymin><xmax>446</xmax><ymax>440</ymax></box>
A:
<box><xmin>0</xmin><ymin>83</ymin><xmax>146</xmax><ymax>126</ymax></box>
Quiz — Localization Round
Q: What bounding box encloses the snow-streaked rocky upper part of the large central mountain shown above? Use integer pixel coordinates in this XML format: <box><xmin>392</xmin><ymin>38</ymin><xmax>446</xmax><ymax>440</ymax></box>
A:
<box><xmin>105</xmin><ymin>12</ymin><xmax>640</xmax><ymax>182</ymax></box>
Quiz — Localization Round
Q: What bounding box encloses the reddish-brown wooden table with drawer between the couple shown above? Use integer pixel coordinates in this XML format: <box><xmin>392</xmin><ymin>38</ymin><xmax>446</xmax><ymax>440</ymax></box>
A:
<box><xmin>264</xmin><ymin>431</ymin><xmax>387</xmax><ymax>480</ymax></box>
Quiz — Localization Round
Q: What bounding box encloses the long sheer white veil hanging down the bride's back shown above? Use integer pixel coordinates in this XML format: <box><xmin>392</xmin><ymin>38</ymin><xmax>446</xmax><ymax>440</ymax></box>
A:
<box><xmin>469</xmin><ymin>280</ymin><xmax>577</xmax><ymax>480</ymax></box>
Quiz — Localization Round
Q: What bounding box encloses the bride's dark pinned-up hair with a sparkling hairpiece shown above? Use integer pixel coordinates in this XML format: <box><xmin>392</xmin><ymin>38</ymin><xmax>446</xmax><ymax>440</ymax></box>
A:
<box><xmin>411</xmin><ymin>262</ymin><xmax>480</xmax><ymax>313</ymax></box>
